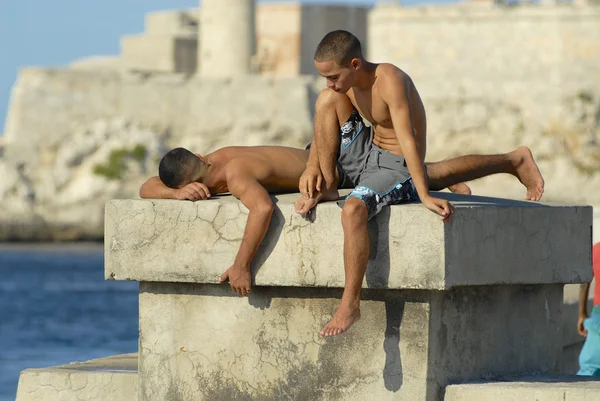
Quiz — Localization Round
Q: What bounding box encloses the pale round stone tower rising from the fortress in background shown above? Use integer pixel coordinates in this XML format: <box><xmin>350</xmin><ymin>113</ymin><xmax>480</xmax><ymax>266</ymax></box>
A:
<box><xmin>197</xmin><ymin>0</ymin><xmax>256</xmax><ymax>77</ymax></box>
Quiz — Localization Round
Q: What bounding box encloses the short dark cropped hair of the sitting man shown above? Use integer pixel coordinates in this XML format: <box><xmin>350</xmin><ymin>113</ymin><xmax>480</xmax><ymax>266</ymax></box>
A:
<box><xmin>315</xmin><ymin>30</ymin><xmax>362</xmax><ymax>66</ymax></box>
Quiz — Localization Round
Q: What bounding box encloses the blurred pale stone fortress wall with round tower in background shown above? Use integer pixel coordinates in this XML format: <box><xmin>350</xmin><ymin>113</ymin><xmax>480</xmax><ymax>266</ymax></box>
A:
<box><xmin>0</xmin><ymin>0</ymin><xmax>600</xmax><ymax>240</ymax></box>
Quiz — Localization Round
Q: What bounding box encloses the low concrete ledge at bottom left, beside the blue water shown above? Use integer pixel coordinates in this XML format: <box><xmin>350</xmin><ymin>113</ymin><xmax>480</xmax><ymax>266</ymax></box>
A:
<box><xmin>16</xmin><ymin>354</ymin><xmax>138</xmax><ymax>401</ymax></box>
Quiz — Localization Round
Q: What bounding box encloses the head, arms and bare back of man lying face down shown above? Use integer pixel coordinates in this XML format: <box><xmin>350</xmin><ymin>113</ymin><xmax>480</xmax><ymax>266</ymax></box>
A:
<box><xmin>140</xmin><ymin>138</ymin><xmax>544</xmax><ymax>296</ymax></box>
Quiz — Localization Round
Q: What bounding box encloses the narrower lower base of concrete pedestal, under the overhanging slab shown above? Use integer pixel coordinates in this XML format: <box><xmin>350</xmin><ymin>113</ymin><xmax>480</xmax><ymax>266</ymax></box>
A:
<box><xmin>140</xmin><ymin>282</ymin><xmax>562</xmax><ymax>401</ymax></box>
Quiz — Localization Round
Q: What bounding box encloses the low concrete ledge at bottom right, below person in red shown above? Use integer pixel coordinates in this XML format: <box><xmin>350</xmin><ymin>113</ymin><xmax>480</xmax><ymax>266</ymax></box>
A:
<box><xmin>444</xmin><ymin>376</ymin><xmax>600</xmax><ymax>401</ymax></box>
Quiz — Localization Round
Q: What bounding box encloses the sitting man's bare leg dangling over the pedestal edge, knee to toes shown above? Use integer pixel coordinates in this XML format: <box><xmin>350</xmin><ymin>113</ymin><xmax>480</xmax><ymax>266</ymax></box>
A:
<box><xmin>321</xmin><ymin>198</ymin><xmax>369</xmax><ymax>336</ymax></box>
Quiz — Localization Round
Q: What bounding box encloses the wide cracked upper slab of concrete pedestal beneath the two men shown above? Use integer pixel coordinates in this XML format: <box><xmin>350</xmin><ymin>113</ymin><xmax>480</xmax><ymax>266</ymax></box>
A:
<box><xmin>105</xmin><ymin>193</ymin><xmax>592</xmax><ymax>290</ymax></box>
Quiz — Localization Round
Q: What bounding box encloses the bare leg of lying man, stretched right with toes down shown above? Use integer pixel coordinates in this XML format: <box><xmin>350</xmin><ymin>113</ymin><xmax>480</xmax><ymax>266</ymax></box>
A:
<box><xmin>427</xmin><ymin>146</ymin><xmax>544</xmax><ymax>201</ymax></box>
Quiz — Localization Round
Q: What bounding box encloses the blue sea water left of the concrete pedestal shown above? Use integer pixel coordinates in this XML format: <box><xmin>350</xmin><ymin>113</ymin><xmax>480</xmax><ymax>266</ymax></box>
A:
<box><xmin>0</xmin><ymin>244</ymin><xmax>138</xmax><ymax>401</ymax></box>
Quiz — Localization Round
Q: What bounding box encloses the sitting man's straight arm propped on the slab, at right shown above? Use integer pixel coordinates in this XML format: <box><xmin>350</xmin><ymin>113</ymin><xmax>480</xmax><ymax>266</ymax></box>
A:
<box><xmin>380</xmin><ymin>71</ymin><xmax>451</xmax><ymax>220</ymax></box>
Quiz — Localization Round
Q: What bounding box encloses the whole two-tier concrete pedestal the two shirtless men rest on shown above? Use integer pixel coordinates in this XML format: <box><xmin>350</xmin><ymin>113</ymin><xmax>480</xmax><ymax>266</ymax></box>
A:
<box><xmin>105</xmin><ymin>191</ymin><xmax>592</xmax><ymax>401</ymax></box>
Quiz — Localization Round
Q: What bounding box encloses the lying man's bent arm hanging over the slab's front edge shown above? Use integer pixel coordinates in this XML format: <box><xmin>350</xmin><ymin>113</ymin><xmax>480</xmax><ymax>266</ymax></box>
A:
<box><xmin>219</xmin><ymin>162</ymin><xmax>275</xmax><ymax>296</ymax></box>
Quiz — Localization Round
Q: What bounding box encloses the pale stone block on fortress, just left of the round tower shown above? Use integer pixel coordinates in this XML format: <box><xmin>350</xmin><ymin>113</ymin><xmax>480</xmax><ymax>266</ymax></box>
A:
<box><xmin>121</xmin><ymin>34</ymin><xmax>198</xmax><ymax>74</ymax></box>
